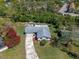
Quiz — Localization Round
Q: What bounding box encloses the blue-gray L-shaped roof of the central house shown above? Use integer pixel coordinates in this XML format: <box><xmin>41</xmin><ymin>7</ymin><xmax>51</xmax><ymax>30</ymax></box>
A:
<box><xmin>25</xmin><ymin>26</ymin><xmax>51</xmax><ymax>38</ymax></box>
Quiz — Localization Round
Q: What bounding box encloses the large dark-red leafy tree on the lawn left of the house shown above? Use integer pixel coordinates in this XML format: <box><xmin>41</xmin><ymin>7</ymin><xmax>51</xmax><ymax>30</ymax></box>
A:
<box><xmin>4</xmin><ymin>28</ymin><xmax>20</xmax><ymax>48</ymax></box>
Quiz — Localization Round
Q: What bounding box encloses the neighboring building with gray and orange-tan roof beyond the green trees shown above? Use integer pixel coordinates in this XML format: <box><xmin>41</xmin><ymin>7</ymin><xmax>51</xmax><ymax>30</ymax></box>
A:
<box><xmin>58</xmin><ymin>2</ymin><xmax>79</xmax><ymax>16</ymax></box>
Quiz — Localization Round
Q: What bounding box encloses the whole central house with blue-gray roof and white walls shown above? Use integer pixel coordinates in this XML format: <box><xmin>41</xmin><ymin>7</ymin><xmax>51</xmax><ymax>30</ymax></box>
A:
<box><xmin>25</xmin><ymin>24</ymin><xmax>51</xmax><ymax>40</ymax></box>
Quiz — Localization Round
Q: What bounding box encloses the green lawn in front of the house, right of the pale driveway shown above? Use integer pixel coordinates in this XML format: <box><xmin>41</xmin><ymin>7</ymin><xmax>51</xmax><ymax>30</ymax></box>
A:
<box><xmin>35</xmin><ymin>43</ymin><xmax>71</xmax><ymax>59</ymax></box>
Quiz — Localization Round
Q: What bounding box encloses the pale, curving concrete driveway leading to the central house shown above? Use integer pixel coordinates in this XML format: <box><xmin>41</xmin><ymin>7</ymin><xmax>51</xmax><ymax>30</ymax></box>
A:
<box><xmin>25</xmin><ymin>34</ymin><xmax>39</xmax><ymax>59</ymax></box>
